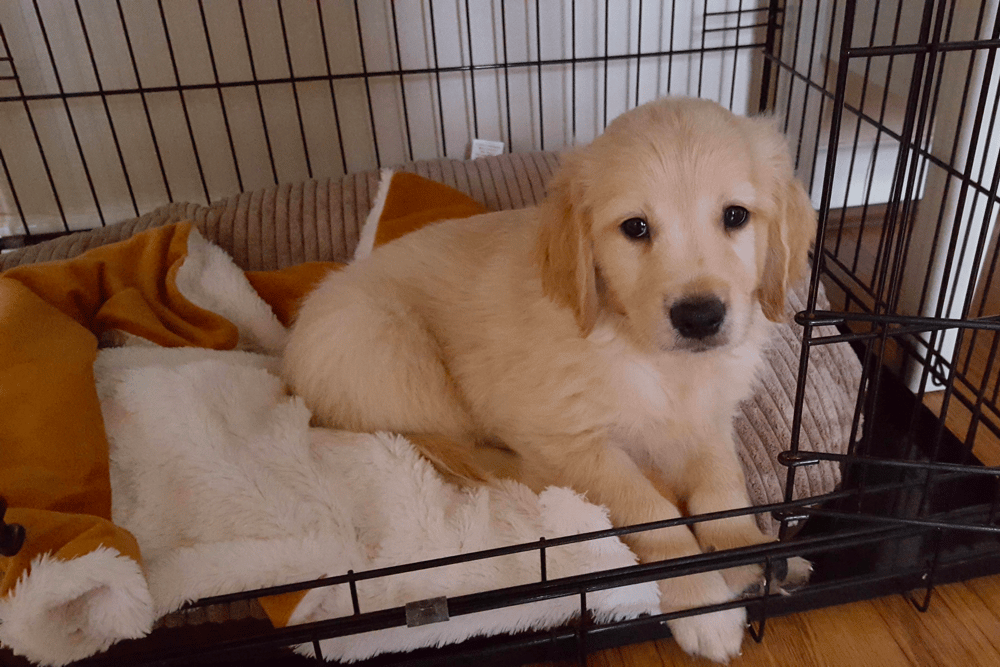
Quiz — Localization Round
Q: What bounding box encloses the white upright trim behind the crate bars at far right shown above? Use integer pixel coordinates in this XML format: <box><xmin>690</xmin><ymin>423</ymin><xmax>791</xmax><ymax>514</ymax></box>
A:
<box><xmin>898</xmin><ymin>0</ymin><xmax>1000</xmax><ymax>392</ymax></box>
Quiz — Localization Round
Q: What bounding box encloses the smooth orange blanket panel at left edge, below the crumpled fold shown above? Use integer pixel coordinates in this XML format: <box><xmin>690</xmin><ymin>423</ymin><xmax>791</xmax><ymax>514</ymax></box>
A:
<box><xmin>0</xmin><ymin>277</ymin><xmax>145</xmax><ymax>604</ymax></box>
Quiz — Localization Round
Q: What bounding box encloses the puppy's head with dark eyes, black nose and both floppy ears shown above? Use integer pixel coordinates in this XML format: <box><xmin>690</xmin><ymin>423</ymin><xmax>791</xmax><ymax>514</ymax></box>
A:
<box><xmin>538</xmin><ymin>98</ymin><xmax>816</xmax><ymax>351</ymax></box>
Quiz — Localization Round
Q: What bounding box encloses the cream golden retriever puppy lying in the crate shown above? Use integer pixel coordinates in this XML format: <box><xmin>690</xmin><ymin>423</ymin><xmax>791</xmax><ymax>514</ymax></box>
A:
<box><xmin>284</xmin><ymin>99</ymin><xmax>816</xmax><ymax>662</ymax></box>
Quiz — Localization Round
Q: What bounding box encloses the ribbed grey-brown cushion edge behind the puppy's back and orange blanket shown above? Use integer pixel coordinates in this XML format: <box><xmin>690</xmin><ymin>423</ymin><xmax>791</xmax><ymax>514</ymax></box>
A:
<box><xmin>0</xmin><ymin>153</ymin><xmax>559</xmax><ymax>271</ymax></box>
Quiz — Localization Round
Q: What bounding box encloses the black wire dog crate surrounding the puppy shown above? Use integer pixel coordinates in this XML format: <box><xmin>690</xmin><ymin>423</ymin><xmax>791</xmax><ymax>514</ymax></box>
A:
<box><xmin>0</xmin><ymin>0</ymin><xmax>1000</xmax><ymax>664</ymax></box>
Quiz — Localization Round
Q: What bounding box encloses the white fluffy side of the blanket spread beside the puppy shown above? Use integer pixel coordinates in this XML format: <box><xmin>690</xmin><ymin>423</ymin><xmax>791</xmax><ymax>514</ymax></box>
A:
<box><xmin>84</xmin><ymin>231</ymin><xmax>658</xmax><ymax>660</ymax></box>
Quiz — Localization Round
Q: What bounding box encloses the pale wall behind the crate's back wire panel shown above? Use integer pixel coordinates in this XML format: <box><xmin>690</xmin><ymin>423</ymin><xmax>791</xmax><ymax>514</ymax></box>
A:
<box><xmin>0</xmin><ymin>0</ymin><xmax>766</xmax><ymax>235</ymax></box>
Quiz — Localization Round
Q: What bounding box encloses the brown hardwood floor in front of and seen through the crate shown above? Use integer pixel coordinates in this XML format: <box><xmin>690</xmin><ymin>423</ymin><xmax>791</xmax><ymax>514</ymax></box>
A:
<box><xmin>536</xmin><ymin>211</ymin><xmax>1000</xmax><ymax>667</ymax></box>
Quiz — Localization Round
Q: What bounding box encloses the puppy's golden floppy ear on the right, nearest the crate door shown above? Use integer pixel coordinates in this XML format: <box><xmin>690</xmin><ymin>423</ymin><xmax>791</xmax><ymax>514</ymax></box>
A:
<box><xmin>748</xmin><ymin>118</ymin><xmax>816</xmax><ymax>322</ymax></box>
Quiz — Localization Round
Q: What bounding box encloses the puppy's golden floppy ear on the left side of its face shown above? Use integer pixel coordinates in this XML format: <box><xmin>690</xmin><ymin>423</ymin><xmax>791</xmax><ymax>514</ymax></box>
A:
<box><xmin>536</xmin><ymin>153</ymin><xmax>598</xmax><ymax>335</ymax></box>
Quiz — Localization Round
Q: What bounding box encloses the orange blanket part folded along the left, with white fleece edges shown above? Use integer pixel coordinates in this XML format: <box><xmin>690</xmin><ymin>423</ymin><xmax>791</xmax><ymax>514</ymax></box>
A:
<box><xmin>0</xmin><ymin>223</ymin><xmax>318</xmax><ymax>664</ymax></box>
